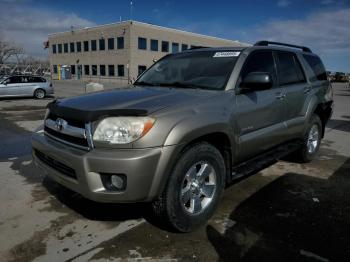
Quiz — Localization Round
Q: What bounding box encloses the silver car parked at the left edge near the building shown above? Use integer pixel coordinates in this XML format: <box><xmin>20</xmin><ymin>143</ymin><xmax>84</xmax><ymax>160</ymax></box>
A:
<box><xmin>0</xmin><ymin>75</ymin><xmax>54</xmax><ymax>99</ymax></box>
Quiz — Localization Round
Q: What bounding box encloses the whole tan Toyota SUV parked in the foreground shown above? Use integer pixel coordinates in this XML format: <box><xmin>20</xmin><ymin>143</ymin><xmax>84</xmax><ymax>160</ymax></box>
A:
<box><xmin>32</xmin><ymin>41</ymin><xmax>333</xmax><ymax>232</ymax></box>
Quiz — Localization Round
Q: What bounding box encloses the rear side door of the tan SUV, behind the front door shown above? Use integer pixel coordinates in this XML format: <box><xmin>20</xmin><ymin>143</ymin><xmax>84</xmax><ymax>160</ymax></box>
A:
<box><xmin>275</xmin><ymin>51</ymin><xmax>311</xmax><ymax>139</ymax></box>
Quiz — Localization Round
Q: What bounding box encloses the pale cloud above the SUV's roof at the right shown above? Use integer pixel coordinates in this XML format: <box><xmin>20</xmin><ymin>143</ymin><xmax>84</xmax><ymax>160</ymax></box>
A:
<box><xmin>248</xmin><ymin>8</ymin><xmax>350</xmax><ymax>53</ymax></box>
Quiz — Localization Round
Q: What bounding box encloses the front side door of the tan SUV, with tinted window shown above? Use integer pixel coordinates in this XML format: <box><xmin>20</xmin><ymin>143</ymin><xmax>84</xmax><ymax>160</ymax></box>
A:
<box><xmin>234</xmin><ymin>50</ymin><xmax>286</xmax><ymax>161</ymax></box>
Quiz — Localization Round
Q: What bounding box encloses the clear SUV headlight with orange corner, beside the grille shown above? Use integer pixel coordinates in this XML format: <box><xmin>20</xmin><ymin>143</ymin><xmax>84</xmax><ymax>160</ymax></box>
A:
<box><xmin>93</xmin><ymin>117</ymin><xmax>155</xmax><ymax>144</ymax></box>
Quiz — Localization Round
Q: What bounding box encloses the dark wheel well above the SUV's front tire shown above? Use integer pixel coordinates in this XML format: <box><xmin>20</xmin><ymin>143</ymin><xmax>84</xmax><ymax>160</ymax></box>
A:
<box><xmin>180</xmin><ymin>132</ymin><xmax>232</xmax><ymax>182</ymax></box>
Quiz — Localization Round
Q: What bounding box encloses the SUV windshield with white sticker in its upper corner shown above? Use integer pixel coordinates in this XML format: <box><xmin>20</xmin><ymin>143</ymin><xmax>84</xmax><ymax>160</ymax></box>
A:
<box><xmin>135</xmin><ymin>51</ymin><xmax>240</xmax><ymax>90</ymax></box>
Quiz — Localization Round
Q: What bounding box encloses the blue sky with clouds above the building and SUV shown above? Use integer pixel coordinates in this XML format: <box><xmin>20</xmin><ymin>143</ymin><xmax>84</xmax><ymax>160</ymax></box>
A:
<box><xmin>0</xmin><ymin>0</ymin><xmax>350</xmax><ymax>72</ymax></box>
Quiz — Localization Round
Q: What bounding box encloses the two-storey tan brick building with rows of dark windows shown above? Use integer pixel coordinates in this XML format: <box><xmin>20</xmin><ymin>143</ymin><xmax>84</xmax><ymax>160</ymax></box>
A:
<box><xmin>49</xmin><ymin>21</ymin><xmax>246</xmax><ymax>85</ymax></box>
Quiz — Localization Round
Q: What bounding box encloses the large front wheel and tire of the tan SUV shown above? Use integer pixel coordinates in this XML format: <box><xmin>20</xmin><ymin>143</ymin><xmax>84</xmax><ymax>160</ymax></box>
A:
<box><xmin>152</xmin><ymin>143</ymin><xmax>225</xmax><ymax>232</ymax></box>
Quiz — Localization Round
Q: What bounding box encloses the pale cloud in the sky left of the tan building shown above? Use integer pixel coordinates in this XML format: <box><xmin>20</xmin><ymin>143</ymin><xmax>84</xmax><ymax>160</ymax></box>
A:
<box><xmin>0</xmin><ymin>0</ymin><xmax>95</xmax><ymax>58</ymax></box>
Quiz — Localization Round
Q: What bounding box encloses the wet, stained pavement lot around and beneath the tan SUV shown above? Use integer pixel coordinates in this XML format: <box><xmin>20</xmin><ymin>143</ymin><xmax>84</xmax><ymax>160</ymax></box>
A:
<box><xmin>0</xmin><ymin>84</ymin><xmax>350</xmax><ymax>261</ymax></box>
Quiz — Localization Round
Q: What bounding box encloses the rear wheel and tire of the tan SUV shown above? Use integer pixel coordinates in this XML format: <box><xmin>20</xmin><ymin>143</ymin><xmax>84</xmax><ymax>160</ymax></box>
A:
<box><xmin>296</xmin><ymin>115</ymin><xmax>322</xmax><ymax>163</ymax></box>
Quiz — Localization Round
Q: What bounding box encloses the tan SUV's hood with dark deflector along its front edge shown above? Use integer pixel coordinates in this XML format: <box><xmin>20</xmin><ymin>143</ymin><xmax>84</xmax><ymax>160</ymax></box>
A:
<box><xmin>48</xmin><ymin>86</ymin><xmax>215</xmax><ymax>122</ymax></box>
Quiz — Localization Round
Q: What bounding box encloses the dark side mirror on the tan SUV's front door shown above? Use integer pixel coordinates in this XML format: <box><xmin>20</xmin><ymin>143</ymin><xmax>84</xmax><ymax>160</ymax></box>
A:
<box><xmin>240</xmin><ymin>72</ymin><xmax>272</xmax><ymax>91</ymax></box>
